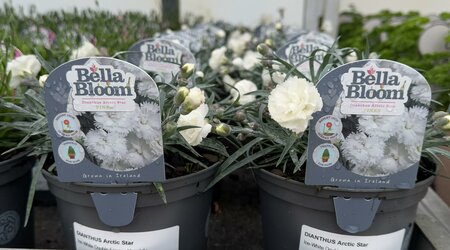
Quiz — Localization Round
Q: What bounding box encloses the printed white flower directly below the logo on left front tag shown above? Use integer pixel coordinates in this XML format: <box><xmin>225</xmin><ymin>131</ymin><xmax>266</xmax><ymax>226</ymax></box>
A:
<box><xmin>94</xmin><ymin>104</ymin><xmax>139</xmax><ymax>135</ymax></box>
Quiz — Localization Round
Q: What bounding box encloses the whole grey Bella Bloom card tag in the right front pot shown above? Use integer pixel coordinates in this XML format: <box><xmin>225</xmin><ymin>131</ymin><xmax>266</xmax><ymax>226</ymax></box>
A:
<box><xmin>305</xmin><ymin>60</ymin><xmax>431</xmax><ymax>189</ymax></box>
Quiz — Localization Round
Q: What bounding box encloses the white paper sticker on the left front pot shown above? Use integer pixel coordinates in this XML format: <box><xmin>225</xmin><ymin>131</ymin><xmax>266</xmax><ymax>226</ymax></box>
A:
<box><xmin>73</xmin><ymin>222</ymin><xmax>180</xmax><ymax>250</ymax></box>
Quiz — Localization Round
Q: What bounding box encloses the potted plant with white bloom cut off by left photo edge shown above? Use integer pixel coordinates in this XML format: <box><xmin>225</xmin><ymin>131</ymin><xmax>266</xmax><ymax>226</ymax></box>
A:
<box><xmin>0</xmin><ymin>42</ymin><xmax>45</xmax><ymax>247</ymax></box>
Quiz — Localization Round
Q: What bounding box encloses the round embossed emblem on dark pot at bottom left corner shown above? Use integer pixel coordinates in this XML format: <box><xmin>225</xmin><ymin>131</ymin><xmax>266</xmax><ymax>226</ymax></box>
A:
<box><xmin>0</xmin><ymin>210</ymin><xmax>20</xmax><ymax>246</ymax></box>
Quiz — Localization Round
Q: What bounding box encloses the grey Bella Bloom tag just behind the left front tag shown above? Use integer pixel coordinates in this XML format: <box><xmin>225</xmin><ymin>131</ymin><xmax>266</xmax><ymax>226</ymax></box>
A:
<box><xmin>127</xmin><ymin>38</ymin><xmax>195</xmax><ymax>82</ymax></box>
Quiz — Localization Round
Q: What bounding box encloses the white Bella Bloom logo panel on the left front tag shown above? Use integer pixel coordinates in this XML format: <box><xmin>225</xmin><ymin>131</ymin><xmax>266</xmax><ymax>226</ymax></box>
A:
<box><xmin>66</xmin><ymin>59</ymin><xmax>136</xmax><ymax>111</ymax></box>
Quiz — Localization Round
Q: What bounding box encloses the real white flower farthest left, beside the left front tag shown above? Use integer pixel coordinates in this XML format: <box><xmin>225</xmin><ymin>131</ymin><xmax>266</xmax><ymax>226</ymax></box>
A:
<box><xmin>6</xmin><ymin>55</ymin><xmax>41</xmax><ymax>88</ymax></box>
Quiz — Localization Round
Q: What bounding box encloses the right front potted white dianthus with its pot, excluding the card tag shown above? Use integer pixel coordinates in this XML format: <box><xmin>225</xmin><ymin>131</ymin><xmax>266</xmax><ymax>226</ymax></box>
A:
<box><xmin>207</xmin><ymin>41</ymin><xmax>450</xmax><ymax>249</ymax></box>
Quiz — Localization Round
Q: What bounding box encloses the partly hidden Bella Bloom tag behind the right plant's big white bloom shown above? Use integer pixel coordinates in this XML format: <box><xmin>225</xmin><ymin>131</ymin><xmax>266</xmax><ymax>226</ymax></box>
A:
<box><xmin>277</xmin><ymin>31</ymin><xmax>334</xmax><ymax>78</ymax></box>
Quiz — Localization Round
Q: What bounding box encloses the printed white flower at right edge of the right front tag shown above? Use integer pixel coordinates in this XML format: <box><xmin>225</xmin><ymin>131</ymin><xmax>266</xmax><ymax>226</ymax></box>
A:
<box><xmin>397</xmin><ymin>106</ymin><xmax>428</xmax><ymax>146</ymax></box>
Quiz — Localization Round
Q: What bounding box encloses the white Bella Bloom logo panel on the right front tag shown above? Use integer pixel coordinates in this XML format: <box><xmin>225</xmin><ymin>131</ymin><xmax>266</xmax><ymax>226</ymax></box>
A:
<box><xmin>341</xmin><ymin>63</ymin><xmax>411</xmax><ymax>115</ymax></box>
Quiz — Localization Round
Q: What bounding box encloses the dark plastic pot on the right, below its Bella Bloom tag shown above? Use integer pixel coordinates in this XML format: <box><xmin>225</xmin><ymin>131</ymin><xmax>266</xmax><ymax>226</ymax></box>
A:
<box><xmin>257</xmin><ymin>170</ymin><xmax>434</xmax><ymax>250</ymax></box>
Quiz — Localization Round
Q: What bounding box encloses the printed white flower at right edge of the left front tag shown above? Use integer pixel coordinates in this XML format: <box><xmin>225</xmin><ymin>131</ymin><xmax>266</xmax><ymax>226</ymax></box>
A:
<box><xmin>133</xmin><ymin>102</ymin><xmax>161</xmax><ymax>142</ymax></box>
